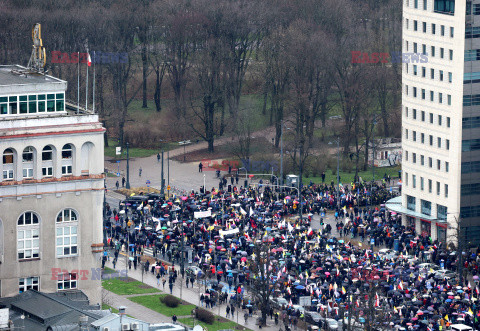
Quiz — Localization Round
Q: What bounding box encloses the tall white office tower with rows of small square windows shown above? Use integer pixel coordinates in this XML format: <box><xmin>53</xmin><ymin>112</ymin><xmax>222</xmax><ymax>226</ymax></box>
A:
<box><xmin>387</xmin><ymin>0</ymin><xmax>480</xmax><ymax>243</ymax></box>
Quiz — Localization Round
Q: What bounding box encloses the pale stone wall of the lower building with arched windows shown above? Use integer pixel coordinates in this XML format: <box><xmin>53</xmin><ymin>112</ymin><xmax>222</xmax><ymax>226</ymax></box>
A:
<box><xmin>0</xmin><ymin>114</ymin><xmax>104</xmax><ymax>304</ymax></box>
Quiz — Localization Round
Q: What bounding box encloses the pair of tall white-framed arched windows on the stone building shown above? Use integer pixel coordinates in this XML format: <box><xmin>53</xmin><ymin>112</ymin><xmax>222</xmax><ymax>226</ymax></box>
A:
<box><xmin>17</xmin><ymin>209</ymin><xmax>78</xmax><ymax>260</ymax></box>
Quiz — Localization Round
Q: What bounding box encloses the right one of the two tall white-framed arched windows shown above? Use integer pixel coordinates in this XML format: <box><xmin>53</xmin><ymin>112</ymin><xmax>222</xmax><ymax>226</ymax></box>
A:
<box><xmin>56</xmin><ymin>209</ymin><xmax>78</xmax><ymax>257</ymax></box>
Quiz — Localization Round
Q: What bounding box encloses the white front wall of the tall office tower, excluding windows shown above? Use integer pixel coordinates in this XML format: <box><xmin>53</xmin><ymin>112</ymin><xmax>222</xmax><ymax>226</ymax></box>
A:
<box><xmin>402</xmin><ymin>0</ymin><xmax>465</xmax><ymax>241</ymax></box>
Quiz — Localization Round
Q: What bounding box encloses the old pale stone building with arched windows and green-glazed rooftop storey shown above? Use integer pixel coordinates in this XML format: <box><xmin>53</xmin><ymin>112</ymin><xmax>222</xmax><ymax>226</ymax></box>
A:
<box><xmin>0</xmin><ymin>66</ymin><xmax>105</xmax><ymax>304</ymax></box>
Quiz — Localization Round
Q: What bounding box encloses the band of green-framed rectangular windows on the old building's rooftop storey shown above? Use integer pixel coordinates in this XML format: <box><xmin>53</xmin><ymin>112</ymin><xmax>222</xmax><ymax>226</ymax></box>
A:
<box><xmin>0</xmin><ymin>93</ymin><xmax>65</xmax><ymax>115</ymax></box>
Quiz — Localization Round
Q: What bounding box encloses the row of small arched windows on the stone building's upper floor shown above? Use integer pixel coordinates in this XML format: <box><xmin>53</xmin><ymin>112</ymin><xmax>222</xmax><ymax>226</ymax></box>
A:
<box><xmin>2</xmin><ymin>144</ymin><xmax>73</xmax><ymax>180</ymax></box>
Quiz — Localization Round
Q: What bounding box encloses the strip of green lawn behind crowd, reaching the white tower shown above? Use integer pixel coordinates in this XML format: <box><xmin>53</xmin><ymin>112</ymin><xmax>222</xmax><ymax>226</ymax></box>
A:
<box><xmin>303</xmin><ymin>166</ymin><xmax>401</xmax><ymax>185</ymax></box>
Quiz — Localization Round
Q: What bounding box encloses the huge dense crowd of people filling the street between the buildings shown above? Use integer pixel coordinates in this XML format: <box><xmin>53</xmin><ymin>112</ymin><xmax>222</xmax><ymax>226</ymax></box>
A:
<box><xmin>103</xmin><ymin>183</ymin><xmax>480</xmax><ymax>330</ymax></box>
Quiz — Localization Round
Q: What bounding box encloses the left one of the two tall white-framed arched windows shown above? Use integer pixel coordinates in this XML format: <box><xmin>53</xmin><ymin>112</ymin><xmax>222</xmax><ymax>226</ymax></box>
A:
<box><xmin>17</xmin><ymin>211</ymin><xmax>40</xmax><ymax>260</ymax></box>
